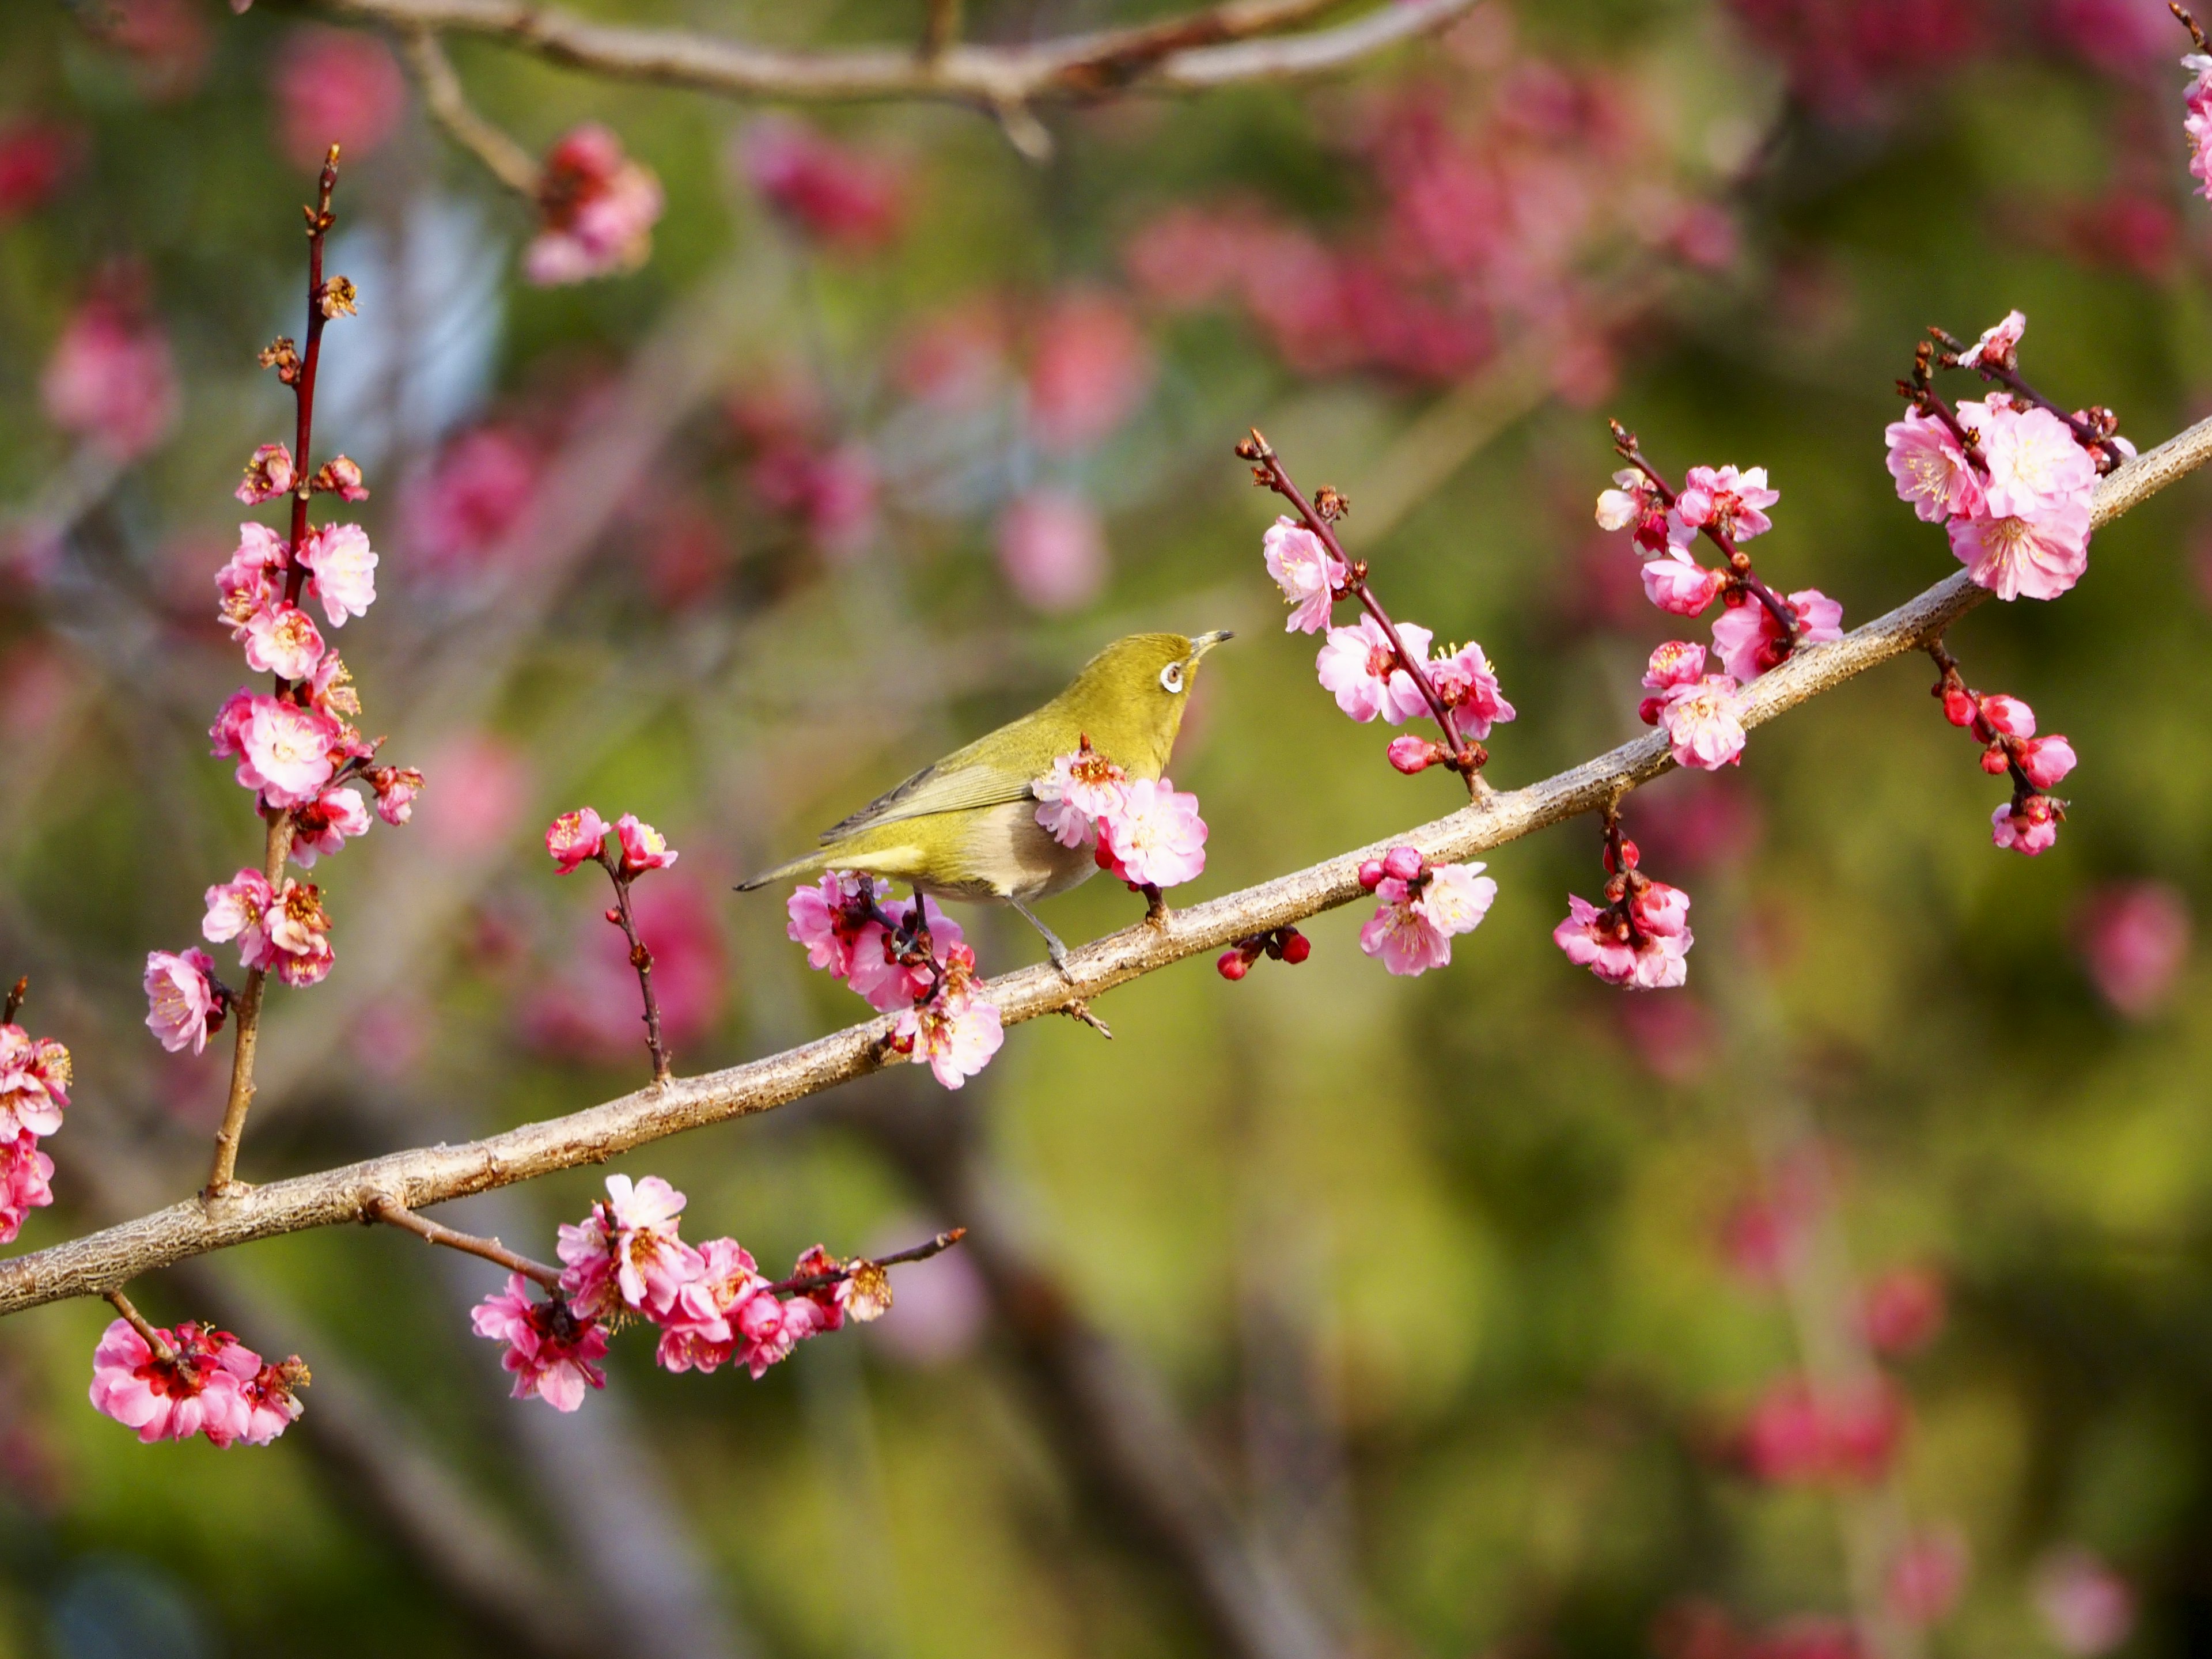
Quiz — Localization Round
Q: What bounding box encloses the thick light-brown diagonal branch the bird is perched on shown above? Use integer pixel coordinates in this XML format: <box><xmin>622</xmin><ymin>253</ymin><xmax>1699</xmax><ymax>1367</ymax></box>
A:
<box><xmin>0</xmin><ymin>421</ymin><xmax>2212</xmax><ymax>1314</ymax></box>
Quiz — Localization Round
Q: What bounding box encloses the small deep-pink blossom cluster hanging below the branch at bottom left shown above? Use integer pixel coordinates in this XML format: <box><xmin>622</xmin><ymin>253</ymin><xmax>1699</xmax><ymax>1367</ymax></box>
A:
<box><xmin>90</xmin><ymin>1319</ymin><xmax>308</xmax><ymax>1449</ymax></box>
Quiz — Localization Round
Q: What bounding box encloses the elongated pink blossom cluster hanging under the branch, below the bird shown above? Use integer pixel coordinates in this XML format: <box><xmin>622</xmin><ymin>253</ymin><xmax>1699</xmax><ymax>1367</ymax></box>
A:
<box><xmin>474</xmin><ymin>1175</ymin><xmax>892</xmax><ymax>1411</ymax></box>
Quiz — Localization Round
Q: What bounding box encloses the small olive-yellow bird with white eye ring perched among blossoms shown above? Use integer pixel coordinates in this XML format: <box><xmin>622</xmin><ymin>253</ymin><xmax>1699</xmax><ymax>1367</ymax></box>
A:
<box><xmin>737</xmin><ymin>628</ymin><xmax>1230</xmax><ymax>967</ymax></box>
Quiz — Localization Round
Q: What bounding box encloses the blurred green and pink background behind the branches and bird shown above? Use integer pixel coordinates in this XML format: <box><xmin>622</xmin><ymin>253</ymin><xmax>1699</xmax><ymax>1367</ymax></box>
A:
<box><xmin>0</xmin><ymin>0</ymin><xmax>2212</xmax><ymax>1659</ymax></box>
